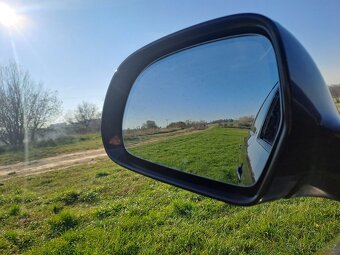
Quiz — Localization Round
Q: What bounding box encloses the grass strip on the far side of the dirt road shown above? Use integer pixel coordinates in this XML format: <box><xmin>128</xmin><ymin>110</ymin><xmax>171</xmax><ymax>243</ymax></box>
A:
<box><xmin>0</xmin><ymin>133</ymin><xmax>103</xmax><ymax>165</ymax></box>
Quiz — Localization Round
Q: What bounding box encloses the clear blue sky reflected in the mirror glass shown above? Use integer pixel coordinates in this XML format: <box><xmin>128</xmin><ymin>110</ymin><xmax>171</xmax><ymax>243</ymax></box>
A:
<box><xmin>123</xmin><ymin>35</ymin><xmax>278</xmax><ymax>129</ymax></box>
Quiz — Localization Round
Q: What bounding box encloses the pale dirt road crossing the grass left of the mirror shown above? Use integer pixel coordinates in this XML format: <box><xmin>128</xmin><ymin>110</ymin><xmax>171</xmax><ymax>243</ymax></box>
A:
<box><xmin>0</xmin><ymin>149</ymin><xmax>107</xmax><ymax>180</ymax></box>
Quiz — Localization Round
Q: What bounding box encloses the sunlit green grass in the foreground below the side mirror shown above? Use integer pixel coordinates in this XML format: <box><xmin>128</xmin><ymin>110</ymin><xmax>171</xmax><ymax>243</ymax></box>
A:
<box><xmin>0</xmin><ymin>159</ymin><xmax>340</xmax><ymax>255</ymax></box>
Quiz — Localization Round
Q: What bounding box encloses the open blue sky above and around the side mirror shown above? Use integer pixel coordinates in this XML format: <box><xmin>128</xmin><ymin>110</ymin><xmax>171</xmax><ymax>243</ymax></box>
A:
<box><xmin>0</xmin><ymin>0</ymin><xmax>340</xmax><ymax>119</ymax></box>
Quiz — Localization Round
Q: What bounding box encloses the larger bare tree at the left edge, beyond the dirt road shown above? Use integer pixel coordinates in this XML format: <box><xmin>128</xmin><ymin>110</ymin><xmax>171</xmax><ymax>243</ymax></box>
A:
<box><xmin>0</xmin><ymin>64</ymin><xmax>61</xmax><ymax>146</ymax></box>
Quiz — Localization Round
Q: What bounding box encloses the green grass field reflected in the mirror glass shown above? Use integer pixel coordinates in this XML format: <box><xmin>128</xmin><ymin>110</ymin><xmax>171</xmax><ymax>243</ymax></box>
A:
<box><xmin>129</xmin><ymin>127</ymin><xmax>252</xmax><ymax>184</ymax></box>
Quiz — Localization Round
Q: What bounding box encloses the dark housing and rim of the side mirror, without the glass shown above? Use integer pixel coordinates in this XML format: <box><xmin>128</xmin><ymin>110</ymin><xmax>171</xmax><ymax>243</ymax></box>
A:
<box><xmin>102</xmin><ymin>14</ymin><xmax>340</xmax><ymax>205</ymax></box>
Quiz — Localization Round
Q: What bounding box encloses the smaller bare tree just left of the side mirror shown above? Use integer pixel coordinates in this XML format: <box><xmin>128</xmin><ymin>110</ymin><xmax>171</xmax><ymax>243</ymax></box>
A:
<box><xmin>68</xmin><ymin>102</ymin><xmax>101</xmax><ymax>131</ymax></box>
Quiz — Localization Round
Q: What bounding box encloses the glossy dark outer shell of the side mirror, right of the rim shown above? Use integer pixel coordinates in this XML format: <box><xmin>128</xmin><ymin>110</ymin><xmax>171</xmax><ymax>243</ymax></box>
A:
<box><xmin>264</xmin><ymin>25</ymin><xmax>340</xmax><ymax>200</ymax></box>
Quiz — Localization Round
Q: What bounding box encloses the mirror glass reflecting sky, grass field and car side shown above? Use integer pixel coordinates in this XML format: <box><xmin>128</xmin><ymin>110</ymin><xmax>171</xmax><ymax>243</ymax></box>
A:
<box><xmin>123</xmin><ymin>35</ymin><xmax>281</xmax><ymax>186</ymax></box>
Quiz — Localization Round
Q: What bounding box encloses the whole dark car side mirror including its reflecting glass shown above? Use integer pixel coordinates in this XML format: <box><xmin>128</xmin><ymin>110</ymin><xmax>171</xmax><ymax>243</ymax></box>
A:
<box><xmin>102</xmin><ymin>14</ymin><xmax>340</xmax><ymax>205</ymax></box>
